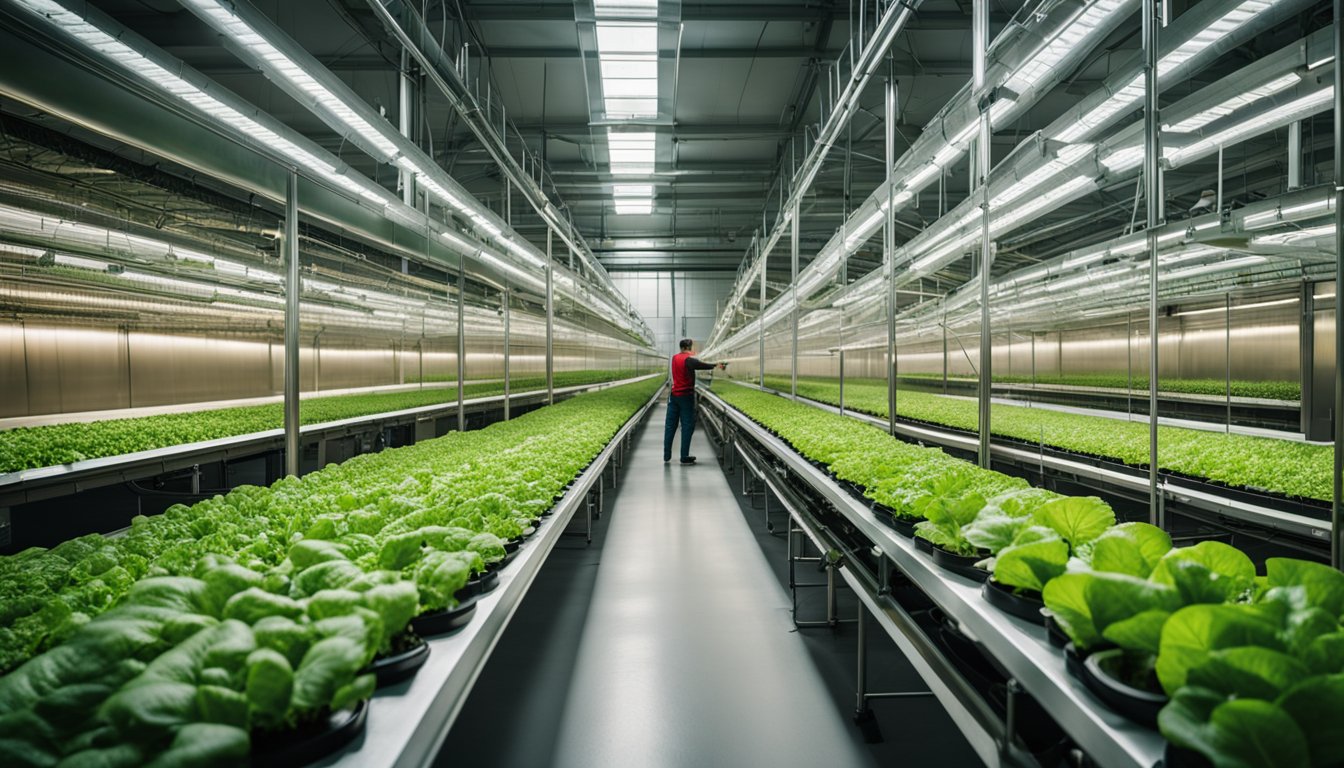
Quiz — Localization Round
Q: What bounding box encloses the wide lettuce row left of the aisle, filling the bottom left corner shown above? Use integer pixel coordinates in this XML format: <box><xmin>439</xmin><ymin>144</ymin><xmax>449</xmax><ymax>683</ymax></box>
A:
<box><xmin>0</xmin><ymin>381</ymin><xmax>659</xmax><ymax>767</ymax></box>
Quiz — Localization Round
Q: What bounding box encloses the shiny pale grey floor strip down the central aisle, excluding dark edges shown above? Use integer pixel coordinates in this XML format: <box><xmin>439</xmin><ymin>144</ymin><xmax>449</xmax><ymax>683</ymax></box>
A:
<box><xmin>554</xmin><ymin>408</ymin><xmax>871</xmax><ymax>768</ymax></box>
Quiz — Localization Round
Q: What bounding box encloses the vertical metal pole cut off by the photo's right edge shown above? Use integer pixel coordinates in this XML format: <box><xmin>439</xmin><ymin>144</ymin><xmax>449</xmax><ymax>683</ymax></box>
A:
<box><xmin>1331</xmin><ymin>0</ymin><xmax>1344</xmax><ymax>568</ymax></box>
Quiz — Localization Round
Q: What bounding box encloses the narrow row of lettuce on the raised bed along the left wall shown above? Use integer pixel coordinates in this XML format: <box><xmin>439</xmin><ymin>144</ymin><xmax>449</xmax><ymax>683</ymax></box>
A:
<box><xmin>0</xmin><ymin>370</ymin><xmax>636</xmax><ymax>475</ymax></box>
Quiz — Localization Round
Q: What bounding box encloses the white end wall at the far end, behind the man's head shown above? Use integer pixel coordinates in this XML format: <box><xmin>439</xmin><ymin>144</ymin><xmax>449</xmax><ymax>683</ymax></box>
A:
<box><xmin>612</xmin><ymin>272</ymin><xmax>732</xmax><ymax>352</ymax></box>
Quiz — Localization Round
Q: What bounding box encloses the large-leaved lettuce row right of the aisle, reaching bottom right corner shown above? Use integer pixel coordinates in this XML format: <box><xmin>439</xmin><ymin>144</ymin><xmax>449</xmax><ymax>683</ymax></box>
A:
<box><xmin>719</xmin><ymin>386</ymin><xmax>1344</xmax><ymax>768</ymax></box>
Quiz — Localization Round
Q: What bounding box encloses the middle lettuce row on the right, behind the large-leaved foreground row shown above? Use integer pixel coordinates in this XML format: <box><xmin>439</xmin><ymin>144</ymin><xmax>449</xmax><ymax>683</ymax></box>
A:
<box><xmin>766</xmin><ymin>377</ymin><xmax>1335</xmax><ymax>502</ymax></box>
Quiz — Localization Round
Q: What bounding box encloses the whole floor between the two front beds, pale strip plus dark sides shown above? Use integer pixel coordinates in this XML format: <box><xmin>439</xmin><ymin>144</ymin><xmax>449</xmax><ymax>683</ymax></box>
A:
<box><xmin>437</xmin><ymin>408</ymin><xmax>973</xmax><ymax>768</ymax></box>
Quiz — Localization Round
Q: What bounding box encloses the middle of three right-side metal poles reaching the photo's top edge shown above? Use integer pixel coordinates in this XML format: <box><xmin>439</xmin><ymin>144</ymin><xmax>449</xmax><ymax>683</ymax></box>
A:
<box><xmin>1142</xmin><ymin>0</ymin><xmax>1161</xmax><ymax>525</ymax></box>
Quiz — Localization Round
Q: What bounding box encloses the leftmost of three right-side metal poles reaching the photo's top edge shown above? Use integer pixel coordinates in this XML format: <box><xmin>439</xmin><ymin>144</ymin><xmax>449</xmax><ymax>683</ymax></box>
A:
<box><xmin>972</xmin><ymin>0</ymin><xmax>995</xmax><ymax>468</ymax></box>
